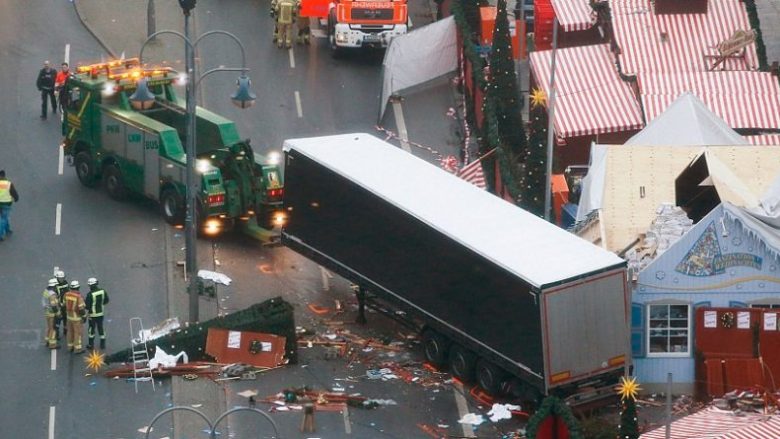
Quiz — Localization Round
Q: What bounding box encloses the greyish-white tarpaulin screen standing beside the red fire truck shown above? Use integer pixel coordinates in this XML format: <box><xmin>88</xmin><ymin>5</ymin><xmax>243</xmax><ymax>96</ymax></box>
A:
<box><xmin>379</xmin><ymin>17</ymin><xmax>458</xmax><ymax>122</ymax></box>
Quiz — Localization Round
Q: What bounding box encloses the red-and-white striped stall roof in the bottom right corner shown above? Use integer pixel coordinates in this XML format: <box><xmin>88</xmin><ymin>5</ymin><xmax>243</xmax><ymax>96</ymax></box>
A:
<box><xmin>639</xmin><ymin>407</ymin><xmax>780</xmax><ymax>439</ymax></box>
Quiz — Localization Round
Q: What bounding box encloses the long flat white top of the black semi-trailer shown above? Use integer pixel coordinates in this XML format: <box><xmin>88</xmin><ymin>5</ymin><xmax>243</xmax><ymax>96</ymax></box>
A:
<box><xmin>284</xmin><ymin>133</ymin><xmax>625</xmax><ymax>289</ymax></box>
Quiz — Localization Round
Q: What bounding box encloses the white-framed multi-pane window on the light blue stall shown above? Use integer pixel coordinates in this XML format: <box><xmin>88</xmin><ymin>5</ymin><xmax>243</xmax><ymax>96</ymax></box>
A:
<box><xmin>647</xmin><ymin>304</ymin><xmax>691</xmax><ymax>357</ymax></box>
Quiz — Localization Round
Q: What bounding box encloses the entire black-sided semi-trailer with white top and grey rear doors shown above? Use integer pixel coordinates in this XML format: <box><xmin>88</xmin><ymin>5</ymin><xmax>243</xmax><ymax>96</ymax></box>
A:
<box><xmin>282</xmin><ymin>134</ymin><xmax>630</xmax><ymax>405</ymax></box>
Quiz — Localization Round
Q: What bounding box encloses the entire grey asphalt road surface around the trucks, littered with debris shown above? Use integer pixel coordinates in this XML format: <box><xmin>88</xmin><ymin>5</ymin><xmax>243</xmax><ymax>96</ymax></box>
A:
<box><xmin>0</xmin><ymin>0</ymin><xmax>506</xmax><ymax>439</ymax></box>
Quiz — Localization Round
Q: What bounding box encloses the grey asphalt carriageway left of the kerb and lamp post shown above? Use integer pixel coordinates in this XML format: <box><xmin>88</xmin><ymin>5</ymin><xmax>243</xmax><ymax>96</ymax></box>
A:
<box><xmin>0</xmin><ymin>0</ymin><xmax>170</xmax><ymax>439</ymax></box>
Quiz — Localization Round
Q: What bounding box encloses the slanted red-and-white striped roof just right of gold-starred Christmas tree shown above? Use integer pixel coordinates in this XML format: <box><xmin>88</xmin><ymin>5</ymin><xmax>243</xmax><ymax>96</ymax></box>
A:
<box><xmin>530</xmin><ymin>44</ymin><xmax>644</xmax><ymax>138</ymax></box>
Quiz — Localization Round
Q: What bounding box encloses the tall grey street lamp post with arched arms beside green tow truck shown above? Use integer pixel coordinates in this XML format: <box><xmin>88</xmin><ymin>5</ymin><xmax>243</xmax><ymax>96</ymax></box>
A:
<box><xmin>135</xmin><ymin>0</ymin><xmax>257</xmax><ymax>323</ymax></box>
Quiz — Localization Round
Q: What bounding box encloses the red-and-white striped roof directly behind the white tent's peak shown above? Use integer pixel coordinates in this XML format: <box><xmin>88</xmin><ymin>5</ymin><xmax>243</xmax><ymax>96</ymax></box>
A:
<box><xmin>637</xmin><ymin>71</ymin><xmax>780</xmax><ymax>129</ymax></box>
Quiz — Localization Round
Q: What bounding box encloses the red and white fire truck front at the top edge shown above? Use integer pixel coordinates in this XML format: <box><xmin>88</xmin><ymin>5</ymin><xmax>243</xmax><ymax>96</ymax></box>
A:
<box><xmin>328</xmin><ymin>0</ymin><xmax>409</xmax><ymax>53</ymax></box>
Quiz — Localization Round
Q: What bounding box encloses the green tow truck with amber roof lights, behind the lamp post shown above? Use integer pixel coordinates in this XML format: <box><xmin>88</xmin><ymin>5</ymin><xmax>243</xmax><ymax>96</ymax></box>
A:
<box><xmin>62</xmin><ymin>59</ymin><xmax>285</xmax><ymax>243</ymax></box>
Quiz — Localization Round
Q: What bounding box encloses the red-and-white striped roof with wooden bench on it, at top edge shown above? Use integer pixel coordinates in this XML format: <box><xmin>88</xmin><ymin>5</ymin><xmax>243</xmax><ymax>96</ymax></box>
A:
<box><xmin>609</xmin><ymin>0</ymin><xmax>758</xmax><ymax>75</ymax></box>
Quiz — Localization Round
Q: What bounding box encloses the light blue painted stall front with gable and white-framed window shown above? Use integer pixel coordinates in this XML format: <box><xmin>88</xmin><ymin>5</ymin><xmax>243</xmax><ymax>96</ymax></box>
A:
<box><xmin>631</xmin><ymin>204</ymin><xmax>780</xmax><ymax>393</ymax></box>
